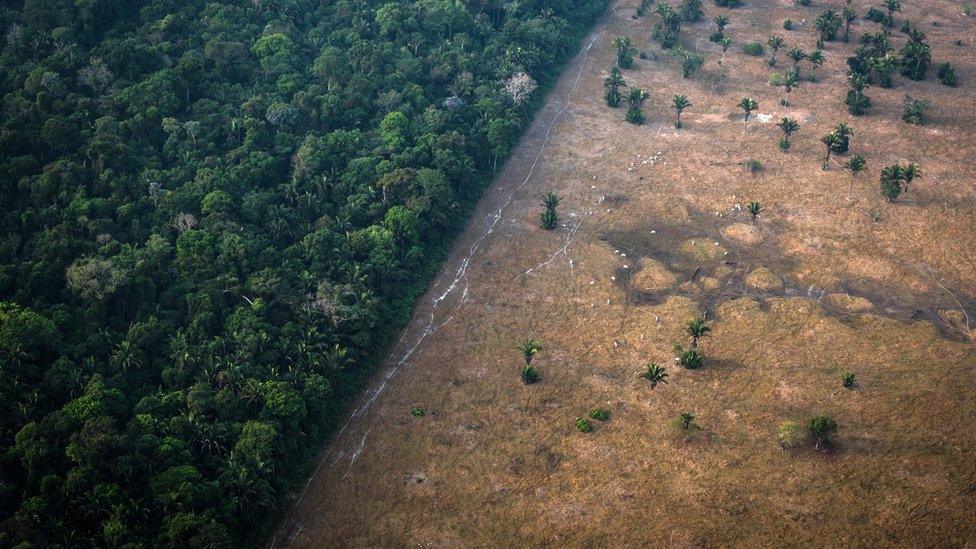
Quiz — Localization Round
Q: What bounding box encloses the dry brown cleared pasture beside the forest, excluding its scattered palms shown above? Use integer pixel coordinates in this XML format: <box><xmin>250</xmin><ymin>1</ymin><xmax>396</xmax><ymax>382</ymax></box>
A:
<box><xmin>276</xmin><ymin>0</ymin><xmax>976</xmax><ymax>546</ymax></box>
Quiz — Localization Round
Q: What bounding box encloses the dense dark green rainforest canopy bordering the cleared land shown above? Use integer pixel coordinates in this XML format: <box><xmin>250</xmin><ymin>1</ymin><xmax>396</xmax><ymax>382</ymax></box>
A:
<box><xmin>0</xmin><ymin>0</ymin><xmax>605</xmax><ymax>546</ymax></box>
